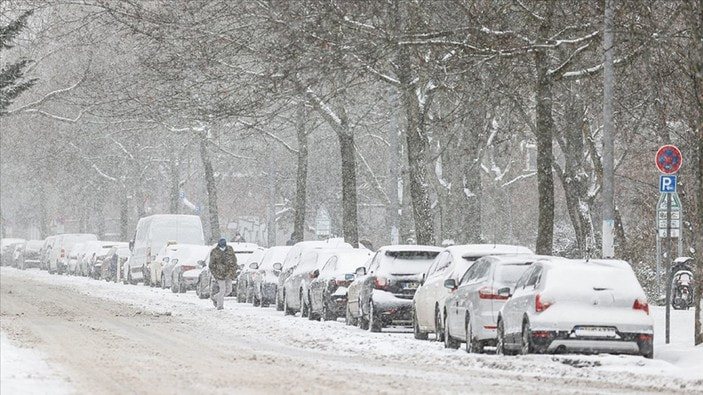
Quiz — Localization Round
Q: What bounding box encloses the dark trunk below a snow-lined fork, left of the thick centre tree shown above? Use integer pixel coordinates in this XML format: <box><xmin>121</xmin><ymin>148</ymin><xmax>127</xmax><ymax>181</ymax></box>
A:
<box><xmin>337</xmin><ymin>132</ymin><xmax>359</xmax><ymax>247</ymax></box>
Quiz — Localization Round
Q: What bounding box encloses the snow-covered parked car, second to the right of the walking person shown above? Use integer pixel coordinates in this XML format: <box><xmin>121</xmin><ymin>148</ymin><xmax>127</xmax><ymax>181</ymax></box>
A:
<box><xmin>252</xmin><ymin>246</ymin><xmax>292</xmax><ymax>307</ymax></box>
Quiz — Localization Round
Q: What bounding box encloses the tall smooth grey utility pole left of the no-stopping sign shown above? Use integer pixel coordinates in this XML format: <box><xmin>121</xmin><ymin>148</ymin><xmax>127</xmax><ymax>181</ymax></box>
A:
<box><xmin>603</xmin><ymin>0</ymin><xmax>615</xmax><ymax>258</ymax></box>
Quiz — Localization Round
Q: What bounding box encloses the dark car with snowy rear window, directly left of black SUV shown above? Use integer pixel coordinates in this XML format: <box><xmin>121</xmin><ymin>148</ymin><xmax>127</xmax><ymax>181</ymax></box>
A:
<box><xmin>308</xmin><ymin>249</ymin><xmax>373</xmax><ymax>321</ymax></box>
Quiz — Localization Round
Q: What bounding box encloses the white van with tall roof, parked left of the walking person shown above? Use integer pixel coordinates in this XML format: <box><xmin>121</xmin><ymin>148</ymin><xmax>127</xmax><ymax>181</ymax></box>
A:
<box><xmin>123</xmin><ymin>214</ymin><xmax>205</xmax><ymax>284</ymax></box>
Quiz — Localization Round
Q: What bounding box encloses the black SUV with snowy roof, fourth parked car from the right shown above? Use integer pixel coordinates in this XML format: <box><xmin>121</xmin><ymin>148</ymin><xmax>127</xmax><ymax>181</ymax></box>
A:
<box><xmin>346</xmin><ymin>245</ymin><xmax>442</xmax><ymax>332</ymax></box>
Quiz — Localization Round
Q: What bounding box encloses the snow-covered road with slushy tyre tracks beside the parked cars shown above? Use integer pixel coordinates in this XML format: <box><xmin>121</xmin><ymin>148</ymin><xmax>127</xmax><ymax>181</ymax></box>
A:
<box><xmin>0</xmin><ymin>267</ymin><xmax>703</xmax><ymax>394</ymax></box>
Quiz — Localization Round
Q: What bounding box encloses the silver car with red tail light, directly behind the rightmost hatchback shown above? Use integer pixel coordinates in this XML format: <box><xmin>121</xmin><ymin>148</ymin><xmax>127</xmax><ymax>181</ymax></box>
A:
<box><xmin>442</xmin><ymin>254</ymin><xmax>540</xmax><ymax>352</ymax></box>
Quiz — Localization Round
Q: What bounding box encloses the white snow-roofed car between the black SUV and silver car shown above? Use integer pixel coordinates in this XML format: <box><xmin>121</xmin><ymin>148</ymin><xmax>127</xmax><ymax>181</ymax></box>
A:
<box><xmin>412</xmin><ymin>244</ymin><xmax>532</xmax><ymax>341</ymax></box>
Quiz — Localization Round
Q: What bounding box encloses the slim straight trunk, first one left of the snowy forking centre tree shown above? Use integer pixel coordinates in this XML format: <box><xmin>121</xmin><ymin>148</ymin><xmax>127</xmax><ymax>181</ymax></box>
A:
<box><xmin>292</xmin><ymin>101</ymin><xmax>308</xmax><ymax>242</ymax></box>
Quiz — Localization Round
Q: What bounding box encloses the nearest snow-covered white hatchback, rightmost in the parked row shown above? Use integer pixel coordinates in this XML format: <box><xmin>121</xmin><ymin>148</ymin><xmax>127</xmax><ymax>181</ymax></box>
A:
<box><xmin>497</xmin><ymin>260</ymin><xmax>654</xmax><ymax>358</ymax></box>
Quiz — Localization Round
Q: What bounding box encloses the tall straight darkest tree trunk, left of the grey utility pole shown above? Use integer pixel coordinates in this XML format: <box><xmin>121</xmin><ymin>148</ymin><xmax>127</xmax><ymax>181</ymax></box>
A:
<box><xmin>535</xmin><ymin>2</ymin><xmax>554</xmax><ymax>255</ymax></box>
